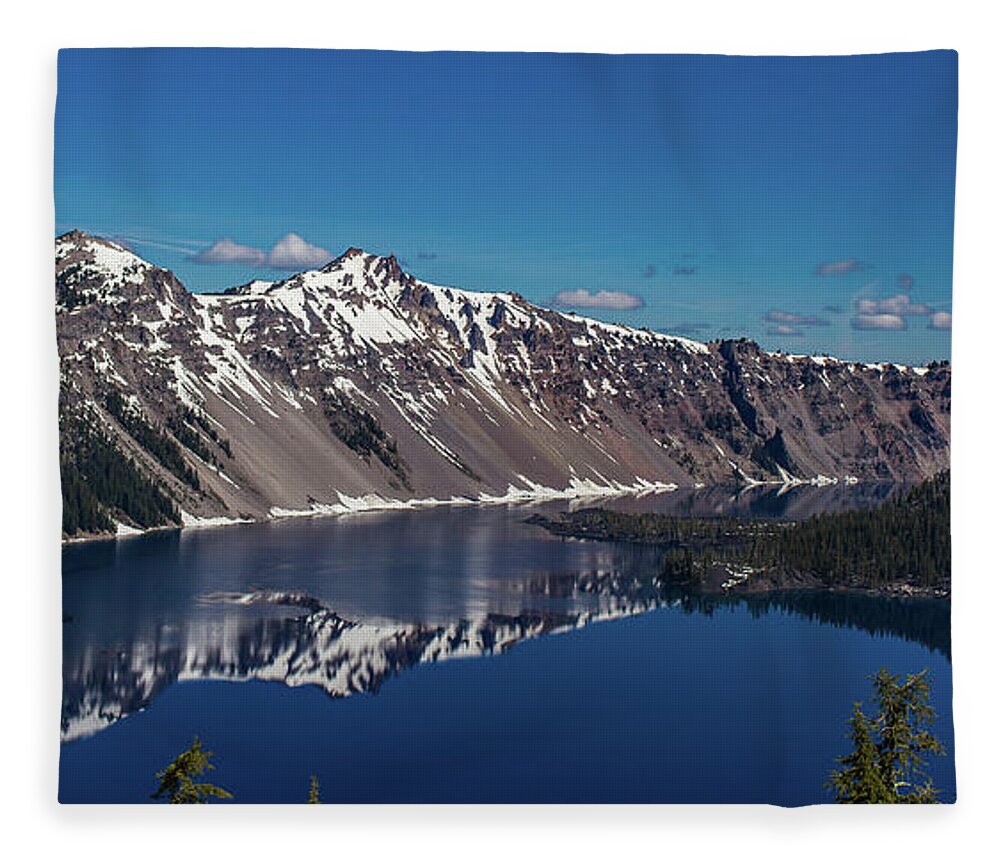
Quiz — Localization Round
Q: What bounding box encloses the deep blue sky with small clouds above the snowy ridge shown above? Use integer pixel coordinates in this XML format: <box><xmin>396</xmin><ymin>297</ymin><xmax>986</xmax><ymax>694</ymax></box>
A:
<box><xmin>55</xmin><ymin>49</ymin><xmax>958</xmax><ymax>362</ymax></box>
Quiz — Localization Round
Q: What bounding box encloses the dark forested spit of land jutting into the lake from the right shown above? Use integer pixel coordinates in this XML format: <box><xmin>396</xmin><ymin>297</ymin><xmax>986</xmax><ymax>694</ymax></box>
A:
<box><xmin>529</xmin><ymin>471</ymin><xmax>951</xmax><ymax>597</ymax></box>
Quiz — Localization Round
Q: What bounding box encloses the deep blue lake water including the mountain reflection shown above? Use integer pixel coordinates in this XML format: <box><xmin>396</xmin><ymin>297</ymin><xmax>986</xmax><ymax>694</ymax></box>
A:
<box><xmin>60</xmin><ymin>491</ymin><xmax>955</xmax><ymax>805</ymax></box>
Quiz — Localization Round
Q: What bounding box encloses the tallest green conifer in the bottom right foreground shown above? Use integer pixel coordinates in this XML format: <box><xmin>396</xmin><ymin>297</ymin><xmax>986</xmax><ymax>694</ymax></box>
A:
<box><xmin>829</xmin><ymin>668</ymin><xmax>945</xmax><ymax>803</ymax></box>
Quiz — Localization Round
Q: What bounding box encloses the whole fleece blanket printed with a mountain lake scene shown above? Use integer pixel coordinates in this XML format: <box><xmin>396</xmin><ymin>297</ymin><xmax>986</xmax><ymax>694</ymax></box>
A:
<box><xmin>54</xmin><ymin>49</ymin><xmax>957</xmax><ymax>806</ymax></box>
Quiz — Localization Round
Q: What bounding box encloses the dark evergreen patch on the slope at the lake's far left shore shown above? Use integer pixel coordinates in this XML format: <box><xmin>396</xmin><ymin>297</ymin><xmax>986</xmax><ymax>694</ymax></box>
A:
<box><xmin>60</xmin><ymin>415</ymin><xmax>179</xmax><ymax>535</ymax></box>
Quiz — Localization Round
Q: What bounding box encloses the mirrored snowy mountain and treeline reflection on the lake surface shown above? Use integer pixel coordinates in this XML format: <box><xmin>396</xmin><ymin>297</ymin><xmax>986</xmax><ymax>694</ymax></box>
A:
<box><xmin>62</xmin><ymin>573</ymin><xmax>949</xmax><ymax>742</ymax></box>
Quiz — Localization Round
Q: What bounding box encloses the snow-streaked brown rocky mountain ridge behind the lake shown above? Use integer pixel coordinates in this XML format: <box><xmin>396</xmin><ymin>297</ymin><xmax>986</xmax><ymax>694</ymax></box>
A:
<box><xmin>56</xmin><ymin>232</ymin><xmax>951</xmax><ymax>531</ymax></box>
